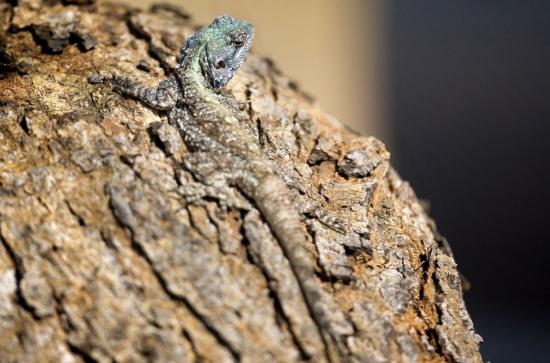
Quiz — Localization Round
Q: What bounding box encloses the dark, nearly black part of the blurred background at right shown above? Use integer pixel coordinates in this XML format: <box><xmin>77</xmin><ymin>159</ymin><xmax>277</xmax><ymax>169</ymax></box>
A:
<box><xmin>388</xmin><ymin>0</ymin><xmax>550</xmax><ymax>363</ymax></box>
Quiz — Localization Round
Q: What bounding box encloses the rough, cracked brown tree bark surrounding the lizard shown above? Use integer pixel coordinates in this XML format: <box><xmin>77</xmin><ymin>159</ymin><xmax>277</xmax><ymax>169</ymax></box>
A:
<box><xmin>0</xmin><ymin>0</ymin><xmax>481</xmax><ymax>362</ymax></box>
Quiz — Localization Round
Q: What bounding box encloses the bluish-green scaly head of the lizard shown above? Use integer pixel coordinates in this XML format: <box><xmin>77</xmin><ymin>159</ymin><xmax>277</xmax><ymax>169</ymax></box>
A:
<box><xmin>180</xmin><ymin>15</ymin><xmax>254</xmax><ymax>88</ymax></box>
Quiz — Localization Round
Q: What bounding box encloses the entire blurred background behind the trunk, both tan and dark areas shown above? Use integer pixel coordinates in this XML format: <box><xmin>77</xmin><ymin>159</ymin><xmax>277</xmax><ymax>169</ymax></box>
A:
<box><xmin>128</xmin><ymin>0</ymin><xmax>550</xmax><ymax>363</ymax></box>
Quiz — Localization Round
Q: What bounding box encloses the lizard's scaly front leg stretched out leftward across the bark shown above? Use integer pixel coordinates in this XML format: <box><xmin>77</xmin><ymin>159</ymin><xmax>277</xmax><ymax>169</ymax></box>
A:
<box><xmin>88</xmin><ymin>73</ymin><xmax>180</xmax><ymax>111</ymax></box>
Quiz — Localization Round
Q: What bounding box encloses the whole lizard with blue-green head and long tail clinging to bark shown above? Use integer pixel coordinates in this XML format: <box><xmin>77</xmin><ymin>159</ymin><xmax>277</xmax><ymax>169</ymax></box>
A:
<box><xmin>89</xmin><ymin>15</ymin><xmax>352</xmax><ymax>355</ymax></box>
